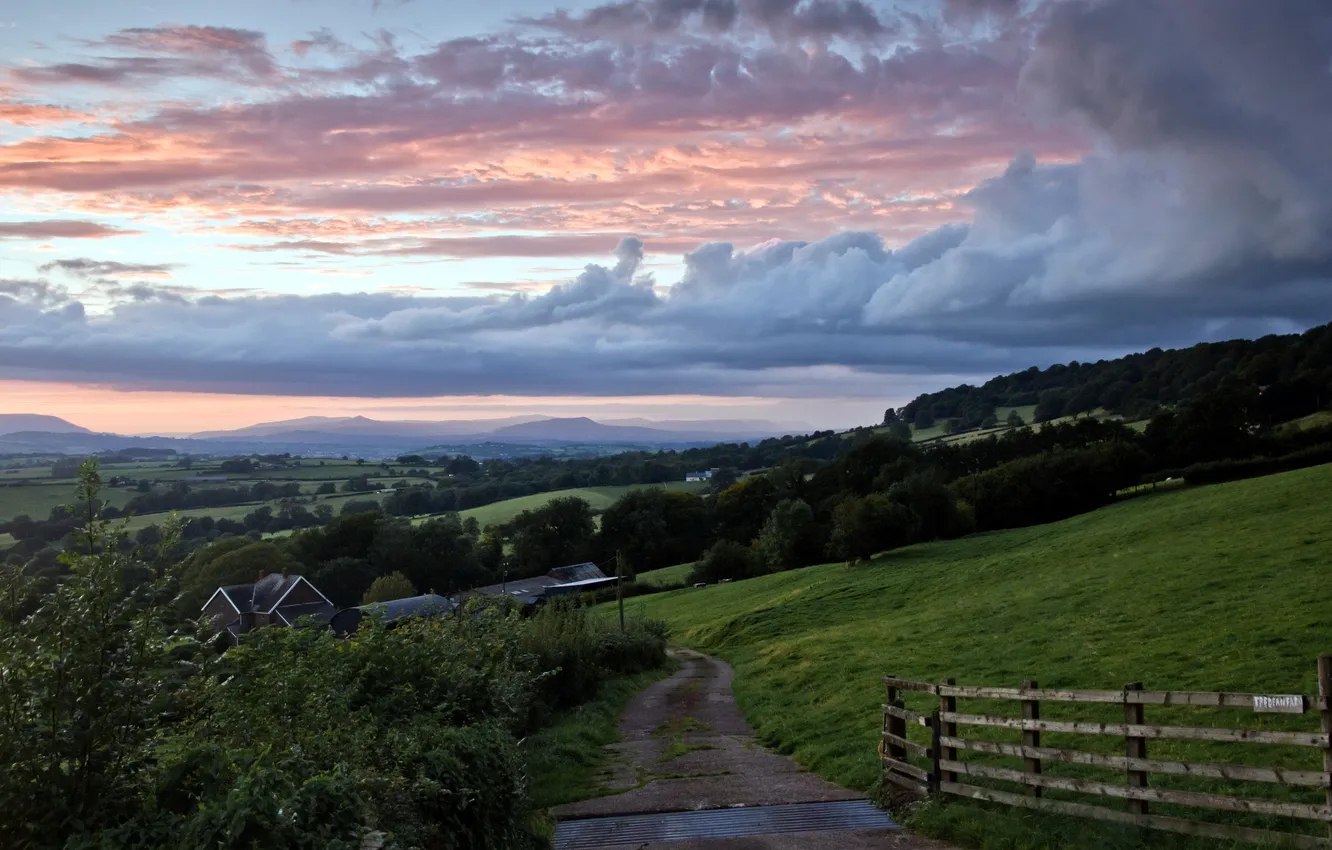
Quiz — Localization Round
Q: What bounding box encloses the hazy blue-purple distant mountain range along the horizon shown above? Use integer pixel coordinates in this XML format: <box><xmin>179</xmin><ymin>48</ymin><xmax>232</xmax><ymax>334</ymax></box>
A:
<box><xmin>0</xmin><ymin>414</ymin><xmax>809</xmax><ymax>457</ymax></box>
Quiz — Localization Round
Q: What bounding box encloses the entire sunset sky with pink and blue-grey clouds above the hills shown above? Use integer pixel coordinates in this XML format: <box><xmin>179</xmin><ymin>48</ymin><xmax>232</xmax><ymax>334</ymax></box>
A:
<box><xmin>0</xmin><ymin>0</ymin><xmax>1332</xmax><ymax>433</ymax></box>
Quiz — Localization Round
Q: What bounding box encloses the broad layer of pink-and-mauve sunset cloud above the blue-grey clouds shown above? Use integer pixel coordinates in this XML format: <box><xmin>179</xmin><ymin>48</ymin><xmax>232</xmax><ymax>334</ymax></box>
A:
<box><xmin>0</xmin><ymin>9</ymin><xmax>1060</xmax><ymax>256</ymax></box>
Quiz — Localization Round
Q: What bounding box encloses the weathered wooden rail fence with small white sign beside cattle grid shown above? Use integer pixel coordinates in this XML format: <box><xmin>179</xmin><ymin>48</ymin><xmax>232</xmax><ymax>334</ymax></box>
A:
<box><xmin>879</xmin><ymin>655</ymin><xmax>1332</xmax><ymax>847</ymax></box>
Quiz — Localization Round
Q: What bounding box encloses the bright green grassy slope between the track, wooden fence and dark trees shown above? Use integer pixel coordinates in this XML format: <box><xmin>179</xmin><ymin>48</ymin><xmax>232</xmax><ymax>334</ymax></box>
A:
<box><xmin>618</xmin><ymin>465</ymin><xmax>1332</xmax><ymax>820</ymax></box>
